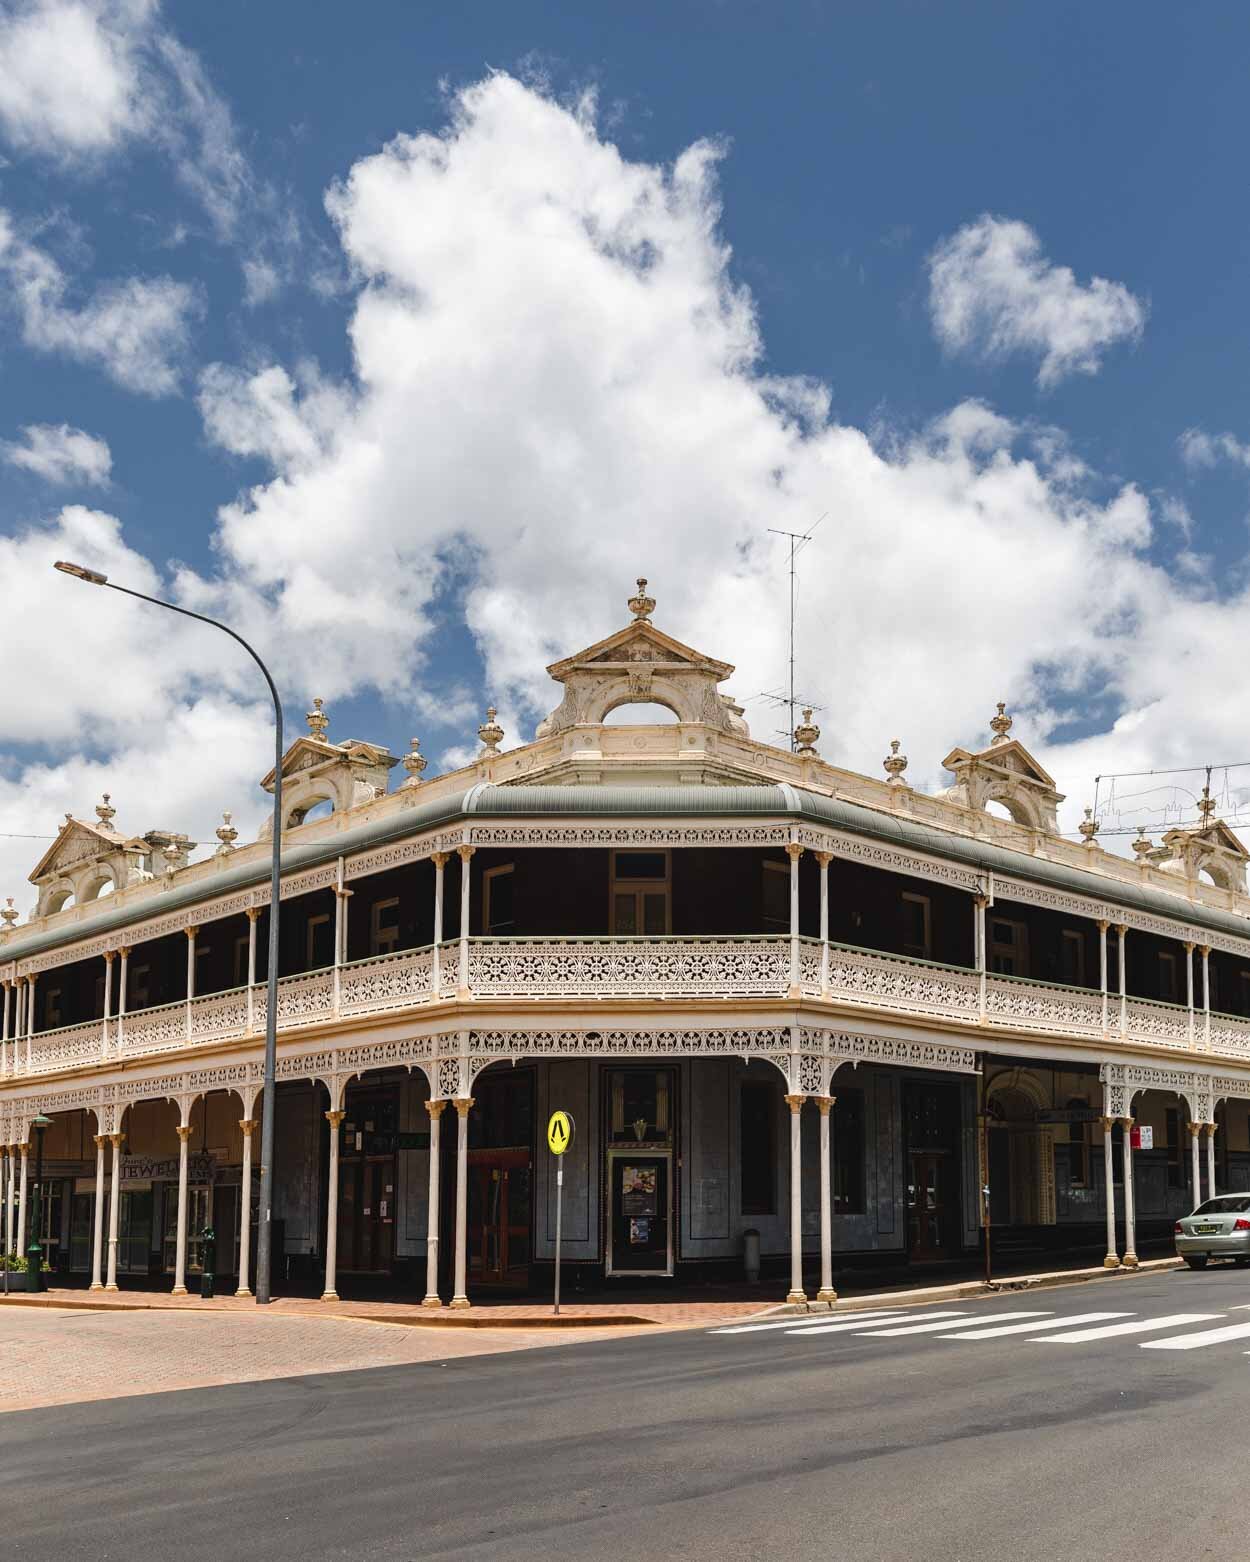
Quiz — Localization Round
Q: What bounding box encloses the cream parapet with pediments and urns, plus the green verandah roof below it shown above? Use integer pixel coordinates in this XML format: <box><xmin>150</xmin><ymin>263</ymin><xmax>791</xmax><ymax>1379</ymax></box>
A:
<box><xmin>0</xmin><ymin>580</ymin><xmax>1250</xmax><ymax>959</ymax></box>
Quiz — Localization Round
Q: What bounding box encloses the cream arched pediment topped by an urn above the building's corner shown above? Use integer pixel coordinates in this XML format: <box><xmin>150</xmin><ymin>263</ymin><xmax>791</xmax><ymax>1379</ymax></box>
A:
<box><xmin>538</xmin><ymin>580</ymin><xmax>744</xmax><ymax>737</ymax></box>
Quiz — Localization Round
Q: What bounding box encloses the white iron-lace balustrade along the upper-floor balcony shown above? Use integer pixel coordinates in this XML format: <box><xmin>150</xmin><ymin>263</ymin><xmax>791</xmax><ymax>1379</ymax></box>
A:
<box><xmin>3</xmin><ymin>934</ymin><xmax>1250</xmax><ymax>1076</ymax></box>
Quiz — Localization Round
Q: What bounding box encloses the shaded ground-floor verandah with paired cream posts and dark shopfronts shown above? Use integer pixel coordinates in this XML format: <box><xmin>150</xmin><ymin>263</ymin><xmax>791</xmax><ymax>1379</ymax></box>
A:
<box><xmin>0</xmin><ymin>1048</ymin><xmax>1250</xmax><ymax>1307</ymax></box>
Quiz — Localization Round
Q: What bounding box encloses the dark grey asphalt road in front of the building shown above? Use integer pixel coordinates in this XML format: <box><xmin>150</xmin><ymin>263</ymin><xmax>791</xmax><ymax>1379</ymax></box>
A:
<box><xmin>0</xmin><ymin>1268</ymin><xmax>1250</xmax><ymax>1562</ymax></box>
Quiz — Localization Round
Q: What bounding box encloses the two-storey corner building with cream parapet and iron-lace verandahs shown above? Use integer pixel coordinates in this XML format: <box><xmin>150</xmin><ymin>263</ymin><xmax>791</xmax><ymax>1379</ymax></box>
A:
<box><xmin>0</xmin><ymin>583</ymin><xmax>1250</xmax><ymax>1306</ymax></box>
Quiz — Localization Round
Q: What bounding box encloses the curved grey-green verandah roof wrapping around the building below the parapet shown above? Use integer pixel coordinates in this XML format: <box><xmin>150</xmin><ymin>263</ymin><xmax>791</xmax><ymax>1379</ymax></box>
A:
<box><xmin>0</xmin><ymin>783</ymin><xmax>1250</xmax><ymax>962</ymax></box>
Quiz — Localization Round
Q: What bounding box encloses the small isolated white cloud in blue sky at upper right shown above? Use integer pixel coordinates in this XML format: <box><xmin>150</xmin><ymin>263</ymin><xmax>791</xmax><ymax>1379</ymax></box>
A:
<box><xmin>928</xmin><ymin>214</ymin><xmax>1147</xmax><ymax>387</ymax></box>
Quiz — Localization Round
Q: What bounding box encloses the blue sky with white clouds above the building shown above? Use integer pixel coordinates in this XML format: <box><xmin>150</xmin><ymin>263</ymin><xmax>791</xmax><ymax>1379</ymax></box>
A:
<box><xmin>0</xmin><ymin>0</ymin><xmax>1250</xmax><ymax>881</ymax></box>
